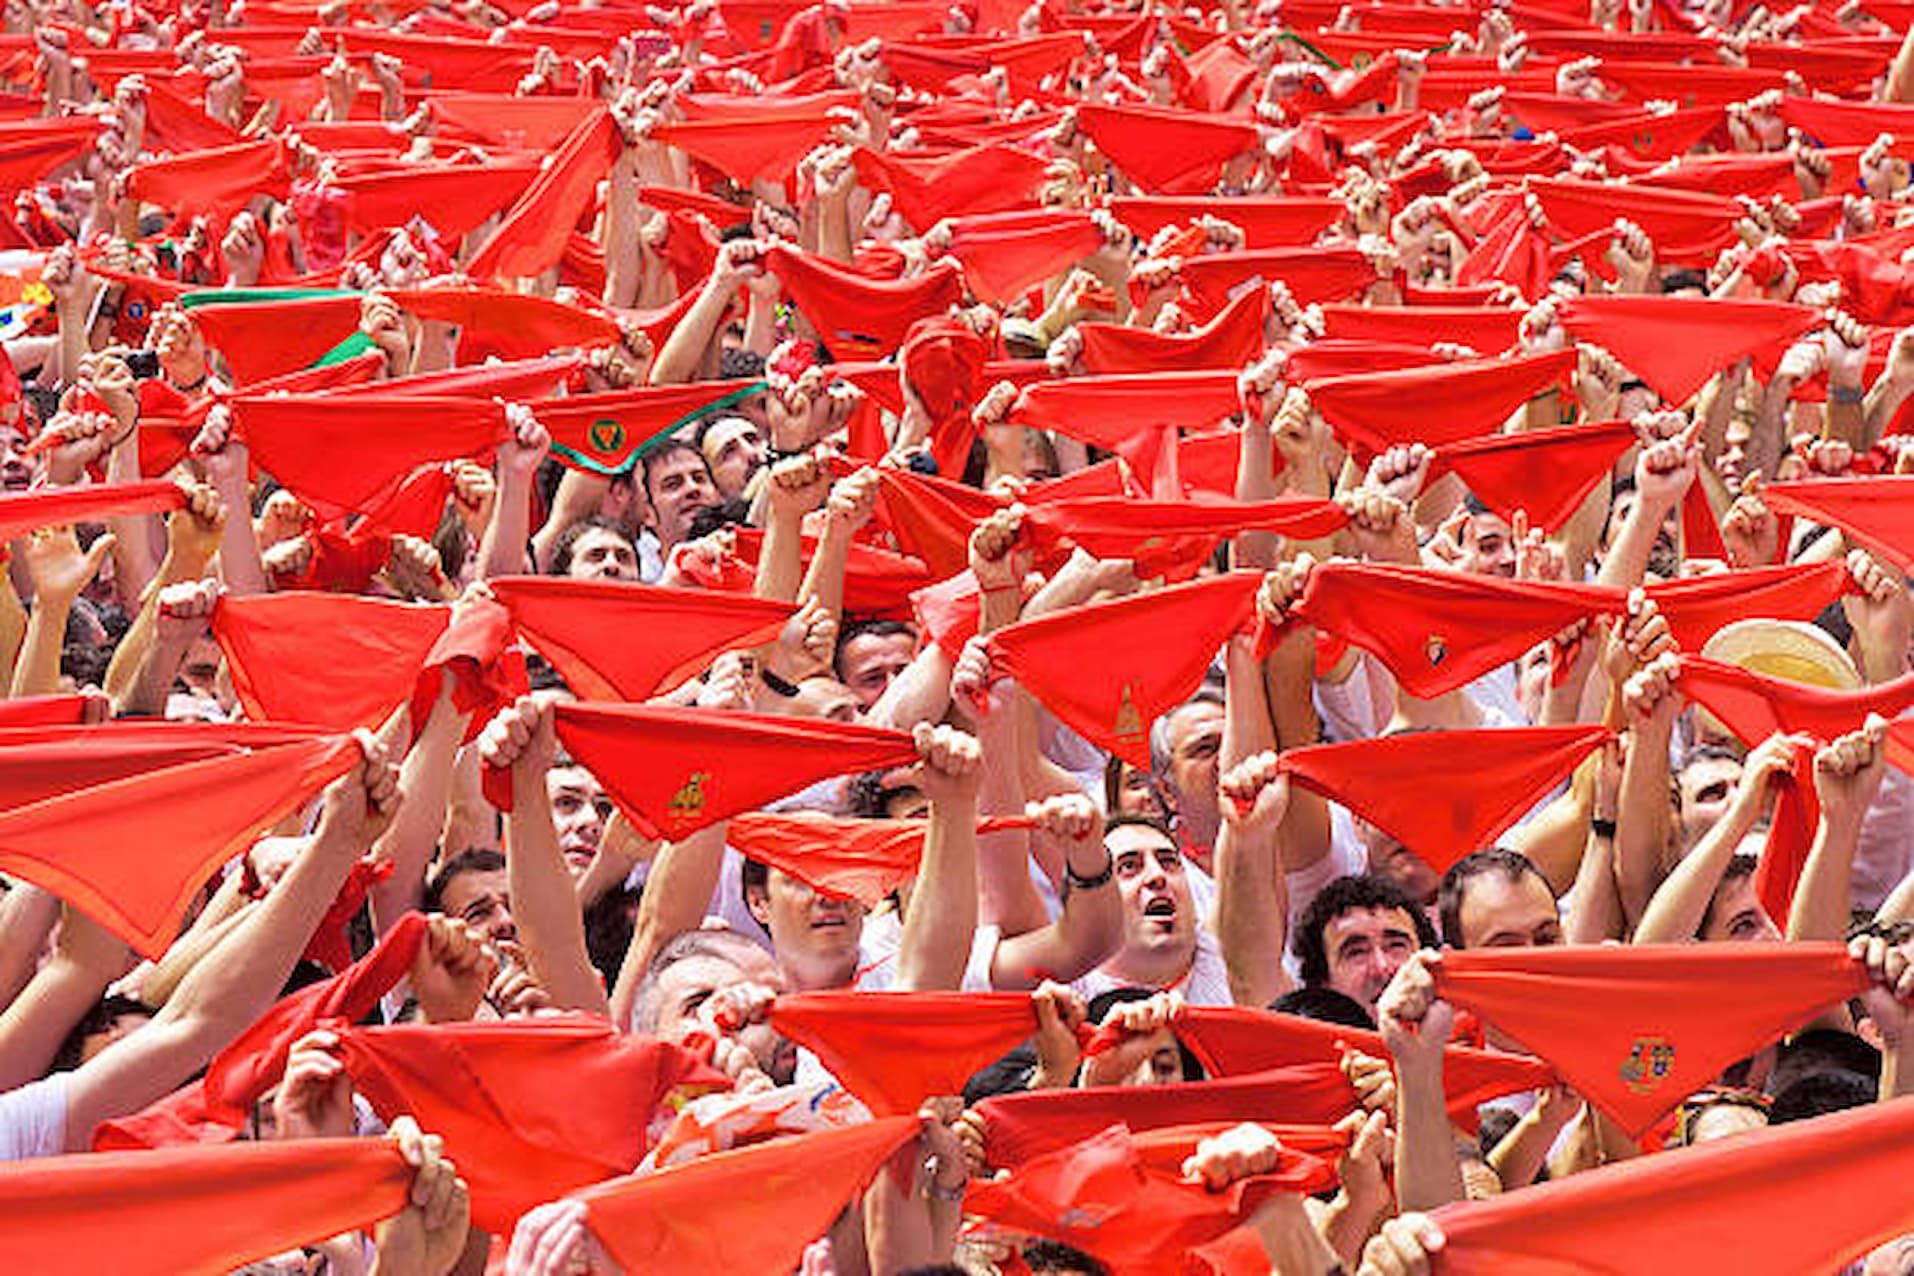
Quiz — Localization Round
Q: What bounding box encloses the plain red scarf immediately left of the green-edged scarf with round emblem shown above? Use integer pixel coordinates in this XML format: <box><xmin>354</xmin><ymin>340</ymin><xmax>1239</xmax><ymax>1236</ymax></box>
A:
<box><xmin>232</xmin><ymin>394</ymin><xmax>507</xmax><ymax>517</ymax></box>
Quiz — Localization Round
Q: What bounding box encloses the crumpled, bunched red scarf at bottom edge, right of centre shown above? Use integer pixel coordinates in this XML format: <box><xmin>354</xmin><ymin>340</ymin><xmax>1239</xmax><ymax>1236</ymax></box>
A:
<box><xmin>965</xmin><ymin>1125</ymin><xmax>1336</xmax><ymax>1276</ymax></box>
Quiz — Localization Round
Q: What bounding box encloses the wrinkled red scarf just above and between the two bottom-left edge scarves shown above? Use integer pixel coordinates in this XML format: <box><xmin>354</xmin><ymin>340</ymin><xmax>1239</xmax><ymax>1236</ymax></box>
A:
<box><xmin>339</xmin><ymin>1016</ymin><xmax>729</xmax><ymax>1234</ymax></box>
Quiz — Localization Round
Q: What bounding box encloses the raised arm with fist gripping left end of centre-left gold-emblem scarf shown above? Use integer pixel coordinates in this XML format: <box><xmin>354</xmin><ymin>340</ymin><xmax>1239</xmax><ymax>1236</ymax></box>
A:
<box><xmin>479</xmin><ymin>696</ymin><xmax>611</xmax><ymax>1014</ymax></box>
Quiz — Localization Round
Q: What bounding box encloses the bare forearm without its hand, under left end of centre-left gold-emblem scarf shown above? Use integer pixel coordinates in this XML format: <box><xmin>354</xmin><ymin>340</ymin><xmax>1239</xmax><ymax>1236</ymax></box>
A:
<box><xmin>505</xmin><ymin>767</ymin><xmax>611</xmax><ymax>1014</ymax></box>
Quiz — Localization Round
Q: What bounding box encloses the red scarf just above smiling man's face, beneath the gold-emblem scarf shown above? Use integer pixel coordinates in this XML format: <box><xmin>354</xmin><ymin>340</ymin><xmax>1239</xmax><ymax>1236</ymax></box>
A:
<box><xmin>727</xmin><ymin>814</ymin><xmax>1032</xmax><ymax>905</ymax></box>
